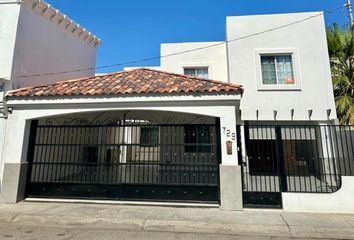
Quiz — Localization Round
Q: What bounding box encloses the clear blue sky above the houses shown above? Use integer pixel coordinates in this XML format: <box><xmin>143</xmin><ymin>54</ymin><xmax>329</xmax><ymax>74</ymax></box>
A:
<box><xmin>47</xmin><ymin>0</ymin><xmax>348</xmax><ymax>72</ymax></box>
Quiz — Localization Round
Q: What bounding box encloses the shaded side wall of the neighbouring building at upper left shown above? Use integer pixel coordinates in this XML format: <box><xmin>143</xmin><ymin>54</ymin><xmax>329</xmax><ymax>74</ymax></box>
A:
<box><xmin>10</xmin><ymin>4</ymin><xmax>96</xmax><ymax>88</ymax></box>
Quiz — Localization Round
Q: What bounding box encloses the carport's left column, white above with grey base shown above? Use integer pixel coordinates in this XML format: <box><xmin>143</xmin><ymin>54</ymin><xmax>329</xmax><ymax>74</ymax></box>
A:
<box><xmin>0</xmin><ymin>114</ymin><xmax>30</xmax><ymax>203</ymax></box>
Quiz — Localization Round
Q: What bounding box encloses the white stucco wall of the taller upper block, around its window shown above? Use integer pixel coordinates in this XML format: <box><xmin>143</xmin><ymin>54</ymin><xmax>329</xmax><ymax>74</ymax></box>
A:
<box><xmin>226</xmin><ymin>12</ymin><xmax>336</xmax><ymax>120</ymax></box>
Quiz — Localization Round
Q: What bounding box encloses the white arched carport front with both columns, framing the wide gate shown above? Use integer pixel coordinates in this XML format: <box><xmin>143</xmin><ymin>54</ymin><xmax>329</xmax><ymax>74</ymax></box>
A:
<box><xmin>0</xmin><ymin>92</ymin><xmax>242</xmax><ymax>209</ymax></box>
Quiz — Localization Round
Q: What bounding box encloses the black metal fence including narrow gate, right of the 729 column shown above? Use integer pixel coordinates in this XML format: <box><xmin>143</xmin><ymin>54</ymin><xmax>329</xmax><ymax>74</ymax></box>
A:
<box><xmin>240</xmin><ymin>125</ymin><xmax>354</xmax><ymax>208</ymax></box>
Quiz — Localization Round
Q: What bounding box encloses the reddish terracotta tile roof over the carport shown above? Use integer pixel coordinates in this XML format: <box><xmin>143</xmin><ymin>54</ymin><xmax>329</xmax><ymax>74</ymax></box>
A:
<box><xmin>7</xmin><ymin>68</ymin><xmax>243</xmax><ymax>97</ymax></box>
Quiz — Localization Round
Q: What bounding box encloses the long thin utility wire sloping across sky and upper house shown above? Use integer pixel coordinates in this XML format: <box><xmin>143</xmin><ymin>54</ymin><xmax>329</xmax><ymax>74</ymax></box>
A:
<box><xmin>0</xmin><ymin>6</ymin><xmax>345</xmax><ymax>79</ymax></box>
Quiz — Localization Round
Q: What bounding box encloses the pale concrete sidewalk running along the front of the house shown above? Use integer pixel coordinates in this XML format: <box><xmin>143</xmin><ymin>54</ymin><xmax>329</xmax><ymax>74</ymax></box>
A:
<box><xmin>0</xmin><ymin>202</ymin><xmax>354</xmax><ymax>239</ymax></box>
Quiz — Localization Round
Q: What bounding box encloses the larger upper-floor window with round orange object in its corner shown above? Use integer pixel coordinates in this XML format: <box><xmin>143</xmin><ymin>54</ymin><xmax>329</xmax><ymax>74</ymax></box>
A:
<box><xmin>261</xmin><ymin>54</ymin><xmax>295</xmax><ymax>85</ymax></box>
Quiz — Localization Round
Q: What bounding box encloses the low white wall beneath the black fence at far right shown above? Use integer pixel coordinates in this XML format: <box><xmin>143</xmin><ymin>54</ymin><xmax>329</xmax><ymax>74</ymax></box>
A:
<box><xmin>282</xmin><ymin>177</ymin><xmax>354</xmax><ymax>213</ymax></box>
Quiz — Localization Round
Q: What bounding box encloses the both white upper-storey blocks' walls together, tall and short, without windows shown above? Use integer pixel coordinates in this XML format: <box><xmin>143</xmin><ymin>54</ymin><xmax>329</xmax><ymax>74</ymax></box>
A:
<box><xmin>161</xmin><ymin>12</ymin><xmax>337</xmax><ymax>121</ymax></box>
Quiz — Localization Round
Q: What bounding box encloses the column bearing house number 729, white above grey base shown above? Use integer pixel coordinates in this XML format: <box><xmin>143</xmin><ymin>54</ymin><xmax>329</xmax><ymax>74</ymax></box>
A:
<box><xmin>220</xmin><ymin>107</ymin><xmax>243</xmax><ymax>211</ymax></box>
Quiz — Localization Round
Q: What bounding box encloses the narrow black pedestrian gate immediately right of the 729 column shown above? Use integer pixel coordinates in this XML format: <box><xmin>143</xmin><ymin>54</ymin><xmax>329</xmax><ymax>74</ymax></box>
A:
<box><xmin>242</xmin><ymin>126</ymin><xmax>281</xmax><ymax>207</ymax></box>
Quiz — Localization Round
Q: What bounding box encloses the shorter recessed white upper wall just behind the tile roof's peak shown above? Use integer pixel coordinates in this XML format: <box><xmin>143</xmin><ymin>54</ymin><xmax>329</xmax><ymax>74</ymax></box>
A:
<box><xmin>161</xmin><ymin>42</ymin><xmax>228</xmax><ymax>82</ymax></box>
